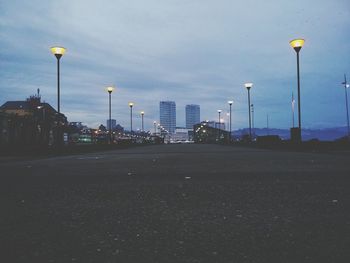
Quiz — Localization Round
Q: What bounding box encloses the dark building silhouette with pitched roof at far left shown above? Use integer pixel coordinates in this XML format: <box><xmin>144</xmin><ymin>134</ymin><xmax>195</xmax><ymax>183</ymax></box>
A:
<box><xmin>0</xmin><ymin>92</ymin><xmax>67</xmax><ymax>148</ymax></box>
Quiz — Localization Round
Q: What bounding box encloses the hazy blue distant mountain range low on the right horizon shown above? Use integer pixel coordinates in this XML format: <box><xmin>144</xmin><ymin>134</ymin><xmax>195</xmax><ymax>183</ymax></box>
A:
<box><xmin>232</xmin><ymin>127</ymin><xmax>348</xmax><ymax>141</ymax></box>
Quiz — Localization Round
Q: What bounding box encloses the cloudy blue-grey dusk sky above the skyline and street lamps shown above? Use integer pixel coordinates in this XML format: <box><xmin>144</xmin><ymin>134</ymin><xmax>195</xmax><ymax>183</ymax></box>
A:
<box><xmin>0</xmin><ymin>0</ymin><xmax>350</xmax><ymax>132</ymax></box>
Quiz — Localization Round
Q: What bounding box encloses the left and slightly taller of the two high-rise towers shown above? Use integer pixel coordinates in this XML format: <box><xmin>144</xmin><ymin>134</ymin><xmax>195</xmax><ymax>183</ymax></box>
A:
<box><xmin>159</xmin><ymin>101</ymin><xmax>176</xmax><ymax>133</ymax></box>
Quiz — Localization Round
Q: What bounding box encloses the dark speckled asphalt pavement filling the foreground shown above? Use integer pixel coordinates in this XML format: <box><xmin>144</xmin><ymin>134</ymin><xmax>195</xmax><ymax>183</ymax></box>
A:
<box><xmin>0</xmin><ymin>145</ymin><xmax>350</xmax><ymax>263</ymax></box>
